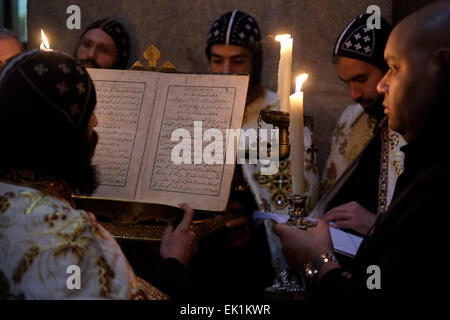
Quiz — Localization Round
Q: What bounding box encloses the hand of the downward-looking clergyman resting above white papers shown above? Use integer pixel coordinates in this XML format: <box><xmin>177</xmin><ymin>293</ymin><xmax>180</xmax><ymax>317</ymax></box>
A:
<box><xmin>322</xmin><ymin>201</ymin><xmax>377</xmax><ymax>235</ymax></box>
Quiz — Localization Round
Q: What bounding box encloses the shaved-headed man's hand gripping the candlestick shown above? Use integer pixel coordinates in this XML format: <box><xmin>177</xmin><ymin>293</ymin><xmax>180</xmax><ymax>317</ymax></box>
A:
<box><xmin>273</xmin><ymin>220</ymin><xmax>333</xmax><ymax>269</ymax></box>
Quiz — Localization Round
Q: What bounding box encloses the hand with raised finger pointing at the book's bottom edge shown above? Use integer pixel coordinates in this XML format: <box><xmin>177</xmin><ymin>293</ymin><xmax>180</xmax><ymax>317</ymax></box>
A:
<box><xmin>159</xmin><ymin>203</ymin><xmax>197</xmax><ymax>268</ymax></box>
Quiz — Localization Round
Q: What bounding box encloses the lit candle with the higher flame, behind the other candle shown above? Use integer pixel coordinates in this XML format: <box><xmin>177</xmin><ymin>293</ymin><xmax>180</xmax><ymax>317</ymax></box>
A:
<box><xmin>275</xmin><ymin>34</ymin><xmax>293</xmax><ymax>112</ymax></box>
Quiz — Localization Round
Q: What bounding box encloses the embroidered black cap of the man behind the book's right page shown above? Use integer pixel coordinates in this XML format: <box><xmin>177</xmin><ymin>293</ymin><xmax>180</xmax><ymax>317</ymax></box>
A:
<box><xmin>205</xmin><ymin>10</ymin><xmax>262</xmax><ymax>86</ymax></box>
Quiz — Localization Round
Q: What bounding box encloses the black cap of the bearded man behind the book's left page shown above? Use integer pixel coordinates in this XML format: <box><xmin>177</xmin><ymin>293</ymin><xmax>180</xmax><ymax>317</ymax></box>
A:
<box><xmin>81</xmin><ymin>18</ymin><xmax>130</xmax><ymax>69</ymax></box>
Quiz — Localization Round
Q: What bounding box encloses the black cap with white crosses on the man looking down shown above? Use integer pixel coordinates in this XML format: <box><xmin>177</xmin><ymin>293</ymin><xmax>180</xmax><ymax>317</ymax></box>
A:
<box><xmin>333</xmin><ymin>14</ymin><xmax>392</xmax><ymax>71</ymax></box>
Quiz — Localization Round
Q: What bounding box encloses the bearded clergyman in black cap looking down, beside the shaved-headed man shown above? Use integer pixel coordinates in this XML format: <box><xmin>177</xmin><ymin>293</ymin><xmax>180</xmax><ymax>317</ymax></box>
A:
<box><xmin>315</xmin><ymin>14</ymin><xmax>405</xmax><ymax>244</ymax></box>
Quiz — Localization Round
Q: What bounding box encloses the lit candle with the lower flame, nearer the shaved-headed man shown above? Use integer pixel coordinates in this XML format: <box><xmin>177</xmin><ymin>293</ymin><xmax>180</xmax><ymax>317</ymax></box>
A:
<box><xmin>289</xmin><ymin>73</ymin><xmax>308</xmax><ymax>194</ymax></box>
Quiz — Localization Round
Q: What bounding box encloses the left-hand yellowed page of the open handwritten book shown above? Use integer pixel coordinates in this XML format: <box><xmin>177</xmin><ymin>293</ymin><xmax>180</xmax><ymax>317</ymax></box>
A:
<box><xmin>88</xmin><ymin>69</ymin><xmax>158</xmax><ymax>200</ymax></box>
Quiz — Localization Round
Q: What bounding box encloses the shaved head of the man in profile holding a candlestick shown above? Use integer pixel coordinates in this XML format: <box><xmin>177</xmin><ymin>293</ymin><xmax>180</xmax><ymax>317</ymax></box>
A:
<box><xmin>377</xmin><ymin>0</ymin><xmax>450</xmax><ymax>143</ymax></box>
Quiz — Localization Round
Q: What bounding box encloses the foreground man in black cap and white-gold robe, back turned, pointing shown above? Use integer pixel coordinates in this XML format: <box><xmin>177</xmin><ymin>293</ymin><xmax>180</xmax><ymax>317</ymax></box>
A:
<box><xmin>0</xmin><ymin>50</ymin><xmax>196</xmax><ymax>300</ymax></box>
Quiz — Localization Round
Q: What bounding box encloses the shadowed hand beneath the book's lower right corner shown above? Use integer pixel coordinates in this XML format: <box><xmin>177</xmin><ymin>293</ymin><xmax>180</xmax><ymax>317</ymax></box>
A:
<box><xmin>225</xmin><ymin>202</ymin><xmax>250</xmax><ymax>248</ymax></box>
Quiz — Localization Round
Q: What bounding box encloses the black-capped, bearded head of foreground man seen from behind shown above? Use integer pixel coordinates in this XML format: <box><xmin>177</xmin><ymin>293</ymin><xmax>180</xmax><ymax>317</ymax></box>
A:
<box><xmin>0</xmin><ymin>50</ymin><xmax>97</xmax><ymax>194</ymax></box>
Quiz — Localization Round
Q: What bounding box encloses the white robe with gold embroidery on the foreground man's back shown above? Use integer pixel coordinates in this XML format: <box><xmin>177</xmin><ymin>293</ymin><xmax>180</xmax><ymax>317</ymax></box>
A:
<box><xmin>0</xmin><ymin>181</ymin><xmax>167</xmax><ymax>299</ymax></box>
